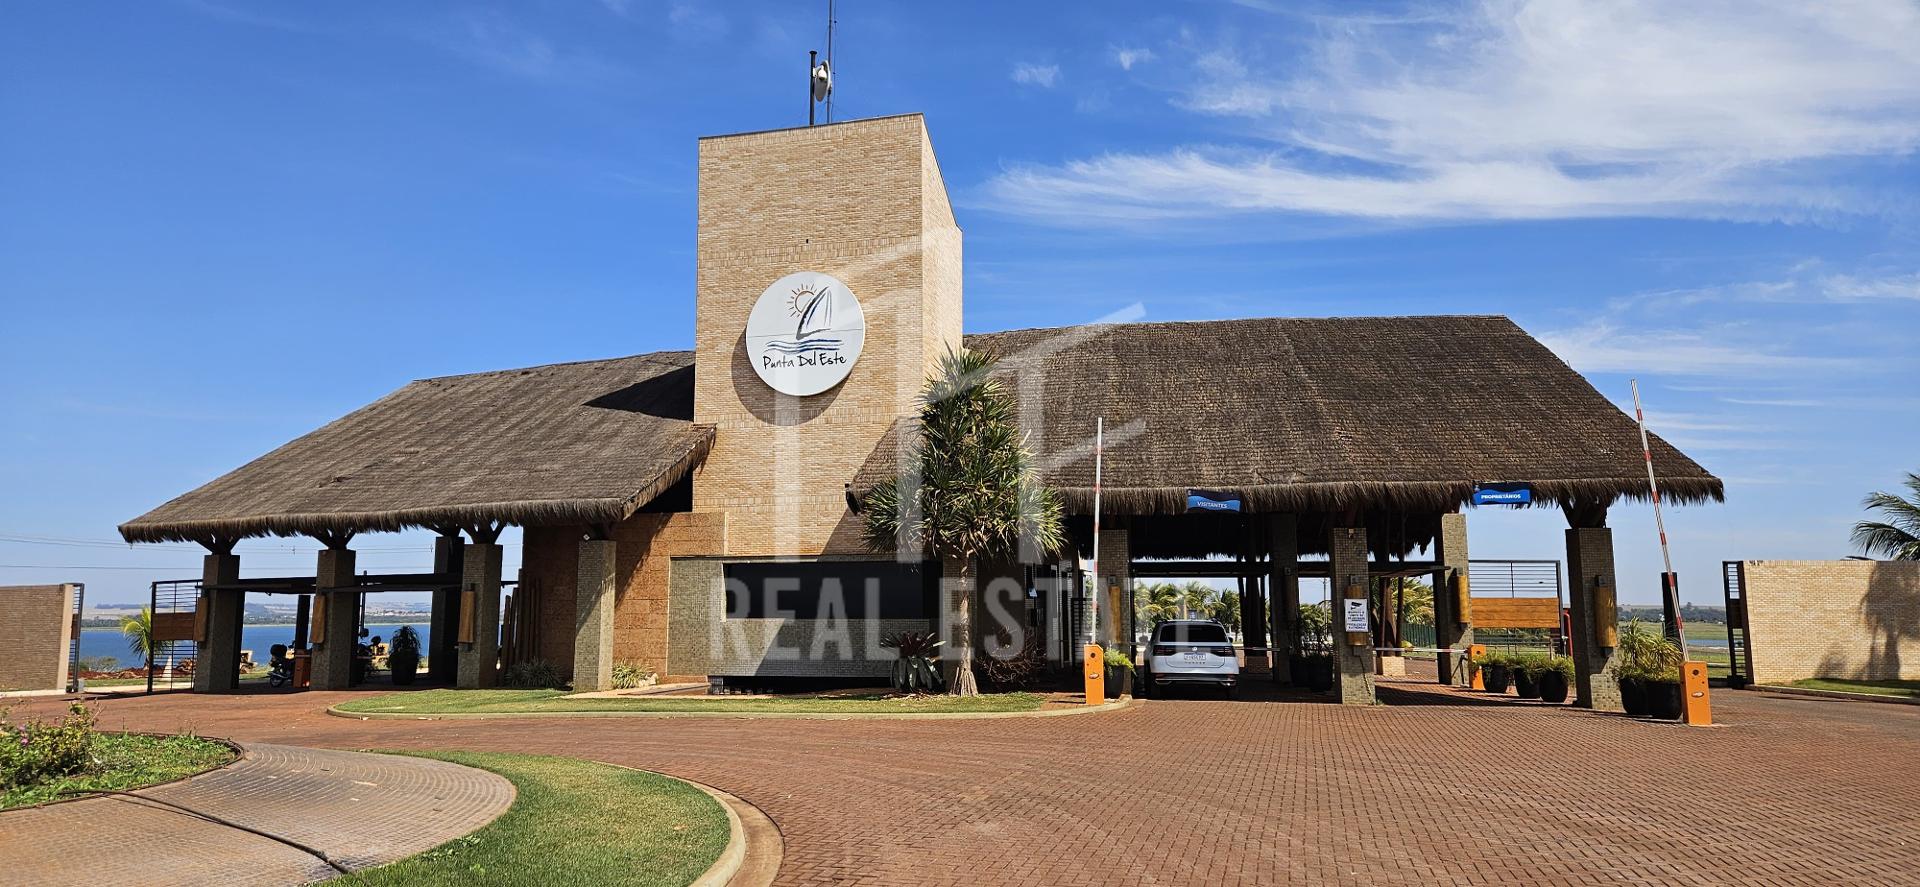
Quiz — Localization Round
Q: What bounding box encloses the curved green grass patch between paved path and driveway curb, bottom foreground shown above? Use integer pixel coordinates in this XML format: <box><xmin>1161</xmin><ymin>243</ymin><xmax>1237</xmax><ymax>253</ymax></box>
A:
<box><xmin>326</xmin><ymin>753</ymin><xmax>728</xmax><ymax>887</ymax></box>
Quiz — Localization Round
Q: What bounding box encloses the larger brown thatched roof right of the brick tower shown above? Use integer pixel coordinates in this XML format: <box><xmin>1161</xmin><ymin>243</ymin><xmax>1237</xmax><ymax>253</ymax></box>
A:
<box><xmin>860</xmin><ymin>317</ymin><xmax>1724</xmax><ymax>515</ymax></box>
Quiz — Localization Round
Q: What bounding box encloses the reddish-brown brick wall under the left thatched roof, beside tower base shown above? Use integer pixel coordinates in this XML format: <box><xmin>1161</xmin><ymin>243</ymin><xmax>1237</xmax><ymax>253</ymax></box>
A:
<box><xmin>520</xmin><ymin>513</ymin><xmax>728</xmax><ymax>683</ymax></box>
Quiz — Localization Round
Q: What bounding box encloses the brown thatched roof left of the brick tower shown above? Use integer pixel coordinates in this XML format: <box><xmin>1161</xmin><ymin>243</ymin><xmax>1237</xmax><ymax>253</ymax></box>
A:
<box><xmin>119</xmin><ymin>351</ymin><xmax>714</xmax><ymax>541</ymax></box>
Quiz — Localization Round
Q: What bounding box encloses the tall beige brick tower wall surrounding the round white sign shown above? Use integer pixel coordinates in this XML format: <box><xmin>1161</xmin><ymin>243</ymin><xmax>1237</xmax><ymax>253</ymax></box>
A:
<box><xmin>693</xmin><ymin>115</ymin><xmax>960</xmax><ymax>555</ymax></box>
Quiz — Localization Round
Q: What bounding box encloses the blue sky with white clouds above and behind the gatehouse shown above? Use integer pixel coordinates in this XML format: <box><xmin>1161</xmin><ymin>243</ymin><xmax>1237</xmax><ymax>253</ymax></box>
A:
<box><xmin>0</xmin><ymin>0</ymin><xmax>1920</xmax><ymax>601</ymax></box>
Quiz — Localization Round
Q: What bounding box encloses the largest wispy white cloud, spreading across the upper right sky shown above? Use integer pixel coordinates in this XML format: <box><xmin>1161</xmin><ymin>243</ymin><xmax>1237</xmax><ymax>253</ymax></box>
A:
<box><xmin>983</xmin><ymin>0</ymin><xmax>1920</xmax><ymax>223</ymax></box>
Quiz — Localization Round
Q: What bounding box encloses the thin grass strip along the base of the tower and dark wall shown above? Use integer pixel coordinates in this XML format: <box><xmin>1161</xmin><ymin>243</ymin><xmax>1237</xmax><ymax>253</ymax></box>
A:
<box><xmin>340</xmin><ymin>689</ymin><xmax>1044</xmax><ymax>714</ymax></box>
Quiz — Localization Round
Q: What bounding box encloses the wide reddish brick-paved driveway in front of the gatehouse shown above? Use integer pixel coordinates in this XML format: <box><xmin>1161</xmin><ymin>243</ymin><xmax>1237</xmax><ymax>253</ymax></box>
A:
<box><xmin>7</xmin><ymin>685</ymin><xmax>1920</xmax><ymax>885</ymax></box>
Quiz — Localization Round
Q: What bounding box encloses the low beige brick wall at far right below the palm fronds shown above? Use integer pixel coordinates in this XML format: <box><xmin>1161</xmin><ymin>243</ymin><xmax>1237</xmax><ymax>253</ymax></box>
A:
<box><xmin>1741</xmin><ymin>561</ymin><xmax>1920</xmax><ymax>683</ymax></box>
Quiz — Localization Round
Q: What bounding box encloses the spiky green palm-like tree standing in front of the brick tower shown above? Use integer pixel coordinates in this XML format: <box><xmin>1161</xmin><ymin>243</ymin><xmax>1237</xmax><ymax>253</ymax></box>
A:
<box><xmin>860</xmin><ymin>348</ymin><xmax>1066</xmax><ymax>697</ymax></box>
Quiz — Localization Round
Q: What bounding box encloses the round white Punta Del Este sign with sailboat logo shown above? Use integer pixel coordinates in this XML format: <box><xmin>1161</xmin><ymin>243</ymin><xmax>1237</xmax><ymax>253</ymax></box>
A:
<box><xmin>747</xmin><ymin>271</ymin><xmax>866</xmax><ymax>397</ymax></box>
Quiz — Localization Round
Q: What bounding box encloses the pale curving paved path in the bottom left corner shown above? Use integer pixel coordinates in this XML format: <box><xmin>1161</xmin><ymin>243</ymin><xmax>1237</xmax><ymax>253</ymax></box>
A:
<box><xmin>0</xmin><ymin>743</ymin><xmax>513</xmax><ymax>887</ymax></box>
